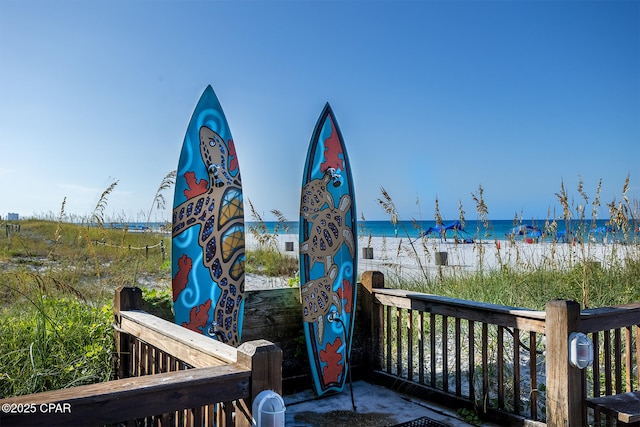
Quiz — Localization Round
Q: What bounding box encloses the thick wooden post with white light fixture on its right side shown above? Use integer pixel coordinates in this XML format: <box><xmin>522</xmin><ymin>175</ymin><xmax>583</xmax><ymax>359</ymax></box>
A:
<box><xmin>545</xmin><ymin>300</ymin><xmax>586</xmax><ymax>427</ymax></box>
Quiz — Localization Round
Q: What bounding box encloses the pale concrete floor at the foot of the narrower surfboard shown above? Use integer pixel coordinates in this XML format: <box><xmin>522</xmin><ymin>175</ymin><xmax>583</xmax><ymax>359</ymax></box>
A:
<box><xmin>284</xmin><ymin>381</ymin><xmax>469</xmax><ymax>427</ymax></box>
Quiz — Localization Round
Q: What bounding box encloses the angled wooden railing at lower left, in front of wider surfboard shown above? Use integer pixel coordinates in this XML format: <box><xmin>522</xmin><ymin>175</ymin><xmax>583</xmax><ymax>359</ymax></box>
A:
<box><xmin>0</xmin><ymin>288</ymin><xmax>282</xmax><ymax>426</ymax></box>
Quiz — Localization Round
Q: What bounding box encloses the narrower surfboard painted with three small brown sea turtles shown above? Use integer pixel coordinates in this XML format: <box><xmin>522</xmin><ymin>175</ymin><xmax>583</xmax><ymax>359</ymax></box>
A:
<box><xmin>299</xmin><ymin>103</ymin><xmax>358</xmax><ymax>396</ymax></box>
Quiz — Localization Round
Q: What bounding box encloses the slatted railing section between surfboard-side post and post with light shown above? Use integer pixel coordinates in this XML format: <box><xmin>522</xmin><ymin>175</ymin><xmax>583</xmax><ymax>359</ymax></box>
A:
<box><xmin>363</xmin><ymin>272</ymin><xmax>545</xmax><ymax>425</ymax></box>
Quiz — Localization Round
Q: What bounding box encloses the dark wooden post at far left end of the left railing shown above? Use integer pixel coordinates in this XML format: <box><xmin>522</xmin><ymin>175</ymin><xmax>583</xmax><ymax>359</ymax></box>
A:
<box><xmin>113</xmin><ymin>286</ymin><xmax>142</xmax><ymax>379</ymax></box>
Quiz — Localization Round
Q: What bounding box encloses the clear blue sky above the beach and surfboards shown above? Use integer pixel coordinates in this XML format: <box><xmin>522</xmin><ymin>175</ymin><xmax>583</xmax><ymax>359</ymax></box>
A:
<box><xmin>0</xmin><ymin>0</ymin><xmax>640</xmax><ymax>224</ymax></box>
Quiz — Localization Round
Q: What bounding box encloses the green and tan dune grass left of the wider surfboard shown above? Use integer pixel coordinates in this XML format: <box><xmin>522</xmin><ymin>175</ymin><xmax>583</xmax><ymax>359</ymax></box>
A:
<box><xmin>0</xmin><ymin>220</ymin><xmax>170</xmax><ymax>397</ymax></box>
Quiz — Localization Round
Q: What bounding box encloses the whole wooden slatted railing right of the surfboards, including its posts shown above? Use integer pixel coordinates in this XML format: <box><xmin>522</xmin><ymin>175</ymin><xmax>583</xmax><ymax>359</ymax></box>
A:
<box><xmin>361</xmin><ymin>272</ymin><xmax>640</xmax><ymax>426</ymax></box>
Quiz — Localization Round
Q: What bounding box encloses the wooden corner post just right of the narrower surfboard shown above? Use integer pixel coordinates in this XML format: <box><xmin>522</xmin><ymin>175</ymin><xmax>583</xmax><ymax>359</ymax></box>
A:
<box><xmin>359</xmin><ymin>271</ymin><xmax>384</xmax><ymax>372</ymax></box>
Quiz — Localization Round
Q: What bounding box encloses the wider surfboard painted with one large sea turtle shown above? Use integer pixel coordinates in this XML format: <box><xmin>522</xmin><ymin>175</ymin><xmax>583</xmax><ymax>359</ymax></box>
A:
<box><xmin>171</xmin><ymin>86</ymin><xmax>245</xmax><ymax>346</ymax></box>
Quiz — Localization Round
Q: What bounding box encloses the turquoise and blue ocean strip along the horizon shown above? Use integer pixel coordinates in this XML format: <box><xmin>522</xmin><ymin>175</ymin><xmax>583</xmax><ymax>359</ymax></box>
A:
<box><xmin>246</xmin><ymin>220</ymin><xmax>639</xmax><ymax>242</ymax></box>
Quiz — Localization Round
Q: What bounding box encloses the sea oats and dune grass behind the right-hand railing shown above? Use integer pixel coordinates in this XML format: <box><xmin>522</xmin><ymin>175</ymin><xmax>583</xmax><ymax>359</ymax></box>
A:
<box><xmin>378</xmin><ymin>177</ymin><xmax>640</xmax><ymax>310</ymax></box>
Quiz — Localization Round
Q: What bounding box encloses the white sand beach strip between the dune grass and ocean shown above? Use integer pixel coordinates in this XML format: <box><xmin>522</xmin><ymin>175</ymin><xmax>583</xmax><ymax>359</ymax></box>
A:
<box><xmin>245</xmin><ymin>233</ymin><xmax>640</xmax><ymax>289</ymax></box>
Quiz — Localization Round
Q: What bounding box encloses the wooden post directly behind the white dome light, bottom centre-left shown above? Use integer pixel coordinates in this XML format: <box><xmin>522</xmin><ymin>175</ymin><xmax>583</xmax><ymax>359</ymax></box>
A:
<box><xmin>236</xmin><ymin>340</ymin><xmax>282</xmax><ymax>427</ymax></box>
